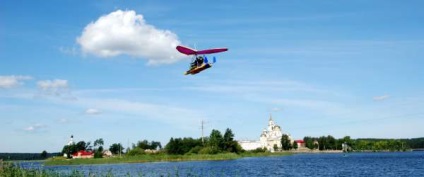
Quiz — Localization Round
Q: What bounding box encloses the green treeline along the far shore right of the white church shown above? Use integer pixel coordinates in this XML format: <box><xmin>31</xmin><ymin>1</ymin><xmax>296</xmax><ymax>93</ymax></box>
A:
<box><xmin>303</xmin><ymin>135</ymin><xmax>424</xmax><ymax>151</ymax></box>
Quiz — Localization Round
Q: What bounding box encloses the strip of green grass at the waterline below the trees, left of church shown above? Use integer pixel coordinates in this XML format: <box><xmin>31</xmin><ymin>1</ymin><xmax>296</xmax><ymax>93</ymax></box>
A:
<box><xmin>44</xmin><ymin>153</ymin><xmax>291</xmax><ymax>165</ymax></box>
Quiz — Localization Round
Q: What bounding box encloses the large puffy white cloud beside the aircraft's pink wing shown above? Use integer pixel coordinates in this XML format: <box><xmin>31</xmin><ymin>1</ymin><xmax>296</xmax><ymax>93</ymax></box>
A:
<box><xmin>77</xmin><ymin>10</ymin><xmax>184</xmax><ymax>64</ymax></box>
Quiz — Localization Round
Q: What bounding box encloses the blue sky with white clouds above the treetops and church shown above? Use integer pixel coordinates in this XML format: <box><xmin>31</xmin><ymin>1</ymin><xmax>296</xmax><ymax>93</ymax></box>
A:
<box><xmin>0</xmin><ymin>0</ymin><xmax>424</xmax><ymax>152</ymax></box>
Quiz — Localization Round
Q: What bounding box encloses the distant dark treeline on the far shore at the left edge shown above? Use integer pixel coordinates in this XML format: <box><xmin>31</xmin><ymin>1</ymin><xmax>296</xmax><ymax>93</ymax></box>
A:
<box><xmin>0</xmin><ymin>151</ymin><xmax>60</xmax><ymax>160</ymax></box>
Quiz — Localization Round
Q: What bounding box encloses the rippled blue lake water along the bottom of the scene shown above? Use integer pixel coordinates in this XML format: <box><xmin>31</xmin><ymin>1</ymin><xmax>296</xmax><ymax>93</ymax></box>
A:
<box><xmin>22</xmin><ymin>152</ymin><xmax>424</xmax><ymax>177</ymax></box>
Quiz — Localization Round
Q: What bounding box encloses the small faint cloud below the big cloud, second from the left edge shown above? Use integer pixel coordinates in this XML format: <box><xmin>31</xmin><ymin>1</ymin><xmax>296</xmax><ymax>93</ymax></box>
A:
<box><xmin>37</xmin><ymin>79</ymin><xmax>69</xmax><ymax>96</ymax></box>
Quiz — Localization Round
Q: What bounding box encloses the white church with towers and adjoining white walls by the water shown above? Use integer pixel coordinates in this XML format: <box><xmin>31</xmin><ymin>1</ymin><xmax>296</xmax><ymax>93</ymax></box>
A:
<box><xmin>238</xmin><ymin>115</ymin><xmax>293</xmax><ymax>152</ymax></box>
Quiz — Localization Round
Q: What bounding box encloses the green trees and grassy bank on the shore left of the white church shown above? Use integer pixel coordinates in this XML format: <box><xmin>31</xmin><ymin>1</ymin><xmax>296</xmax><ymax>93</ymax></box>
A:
<box><xmin>45</xmin><ymin>128</ymin><xmax>290</xmax><ymax>165</ymax></box>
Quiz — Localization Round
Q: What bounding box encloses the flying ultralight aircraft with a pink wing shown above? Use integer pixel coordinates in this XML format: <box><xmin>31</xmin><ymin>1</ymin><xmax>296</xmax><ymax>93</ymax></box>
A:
<box><xmin>177</xmin><ymin>45</ymin><xmax>228</xmax><ymax>75</ymax></box>
